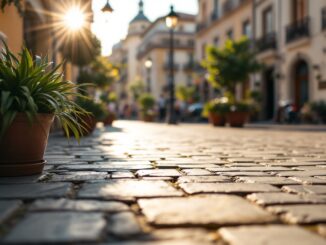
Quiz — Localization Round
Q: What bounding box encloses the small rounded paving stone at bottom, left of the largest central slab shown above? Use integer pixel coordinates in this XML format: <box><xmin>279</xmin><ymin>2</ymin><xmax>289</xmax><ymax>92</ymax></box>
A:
<box><xmin>108</xmin><ymin>212</ymin><xmax>143</xmax><ymax>237</ymax></box>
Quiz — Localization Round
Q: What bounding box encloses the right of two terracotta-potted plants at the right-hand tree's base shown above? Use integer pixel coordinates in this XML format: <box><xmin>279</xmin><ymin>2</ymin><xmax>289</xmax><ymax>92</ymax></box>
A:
<box><xmin>227</xmin><ymin>102</ymin><xmax>251</xmax><ymax>128</ymax></box>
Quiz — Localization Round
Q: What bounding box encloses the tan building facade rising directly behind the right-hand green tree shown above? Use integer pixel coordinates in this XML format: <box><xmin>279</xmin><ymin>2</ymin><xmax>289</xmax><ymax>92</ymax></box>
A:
<box><xmin>196</xmin><ymin>0</ymin><xmax>253</xmax><ymax>102</ymax></box>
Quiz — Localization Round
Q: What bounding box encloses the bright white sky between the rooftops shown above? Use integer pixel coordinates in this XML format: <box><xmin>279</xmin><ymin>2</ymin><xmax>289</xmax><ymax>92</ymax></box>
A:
<box><xmin>93</xmin><ymin>0</ymin><xmax>198</xmax><ymax>55</ymax></box>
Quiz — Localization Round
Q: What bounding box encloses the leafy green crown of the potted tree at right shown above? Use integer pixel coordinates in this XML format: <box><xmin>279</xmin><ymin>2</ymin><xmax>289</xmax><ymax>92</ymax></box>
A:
<box><xmin>203</xmin><ymin>38</ymin><xmax>262</xmax><ymax>94</ymax></box>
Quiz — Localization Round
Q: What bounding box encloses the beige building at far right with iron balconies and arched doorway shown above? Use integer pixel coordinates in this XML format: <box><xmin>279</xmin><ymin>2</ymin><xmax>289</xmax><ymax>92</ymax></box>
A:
<box><xmin>254</xmin><ymin>0</ymin><xmax>326</xmax><ymax>119</ymax></box>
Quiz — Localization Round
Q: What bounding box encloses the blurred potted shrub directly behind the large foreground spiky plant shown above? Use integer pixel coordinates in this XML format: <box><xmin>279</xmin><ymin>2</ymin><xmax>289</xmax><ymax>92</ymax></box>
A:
<box><xmin>76</xmin><ymin>97</ymin><xmax>108</xmax><ymax>136</ymax></box>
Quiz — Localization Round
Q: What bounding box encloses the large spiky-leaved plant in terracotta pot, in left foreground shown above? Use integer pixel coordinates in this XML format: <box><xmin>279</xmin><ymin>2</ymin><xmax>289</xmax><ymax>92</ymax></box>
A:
<box><xmin>0</xmin><ymin>43</ymin><xmax>87</xmax><ymax>176</ymax></box>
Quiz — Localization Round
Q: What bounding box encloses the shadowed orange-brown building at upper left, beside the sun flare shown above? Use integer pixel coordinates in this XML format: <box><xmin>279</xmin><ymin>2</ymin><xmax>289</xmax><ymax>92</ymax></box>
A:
<box><xmin>0</xmin><ymin>0</ymin><xmax>93</xmax><ymax>81</ymax></box>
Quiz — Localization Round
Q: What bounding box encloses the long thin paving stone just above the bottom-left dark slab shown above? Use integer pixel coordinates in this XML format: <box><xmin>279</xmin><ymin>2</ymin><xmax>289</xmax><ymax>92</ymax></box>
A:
<box><xmin>30</xmin><ymin>199</ymin><xmax>129</xmax><ymax>213</ymax></box>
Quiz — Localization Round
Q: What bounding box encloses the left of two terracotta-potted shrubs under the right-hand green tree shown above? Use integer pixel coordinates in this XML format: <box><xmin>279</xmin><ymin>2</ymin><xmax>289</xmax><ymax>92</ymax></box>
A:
<box><xmin>203</xmin><ymin>97</ymin><xmax>230</xmax><ymax>126</ymax></box>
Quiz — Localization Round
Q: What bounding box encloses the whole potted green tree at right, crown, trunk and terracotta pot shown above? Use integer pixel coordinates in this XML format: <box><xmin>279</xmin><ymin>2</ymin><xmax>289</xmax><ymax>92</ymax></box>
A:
<box><xmin>203</xmin><ymin>38</ymin><xmax>262</xmax><ymax>127</ymax></box>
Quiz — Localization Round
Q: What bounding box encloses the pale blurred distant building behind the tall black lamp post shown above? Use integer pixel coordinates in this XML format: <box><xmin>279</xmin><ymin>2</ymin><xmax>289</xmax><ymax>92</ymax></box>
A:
<box><xmin>137</xmin><ymin>13</ymin><xmax>195</xmax><ymax>99</ymax></box>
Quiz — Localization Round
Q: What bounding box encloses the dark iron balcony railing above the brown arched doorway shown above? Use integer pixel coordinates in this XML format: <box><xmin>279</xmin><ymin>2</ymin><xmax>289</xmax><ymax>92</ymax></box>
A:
<box><xmin>286</xmin><ymin>17</ymin><xmax>310</xmax><ymax>43</ymax></box>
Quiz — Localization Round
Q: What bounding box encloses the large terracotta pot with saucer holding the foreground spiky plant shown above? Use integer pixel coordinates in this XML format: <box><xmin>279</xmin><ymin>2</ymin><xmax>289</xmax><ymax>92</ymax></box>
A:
<box><xmin>0</xmin><ymin>113</ymin><xmax>54</xmax><ymax>177</ymax></box>
